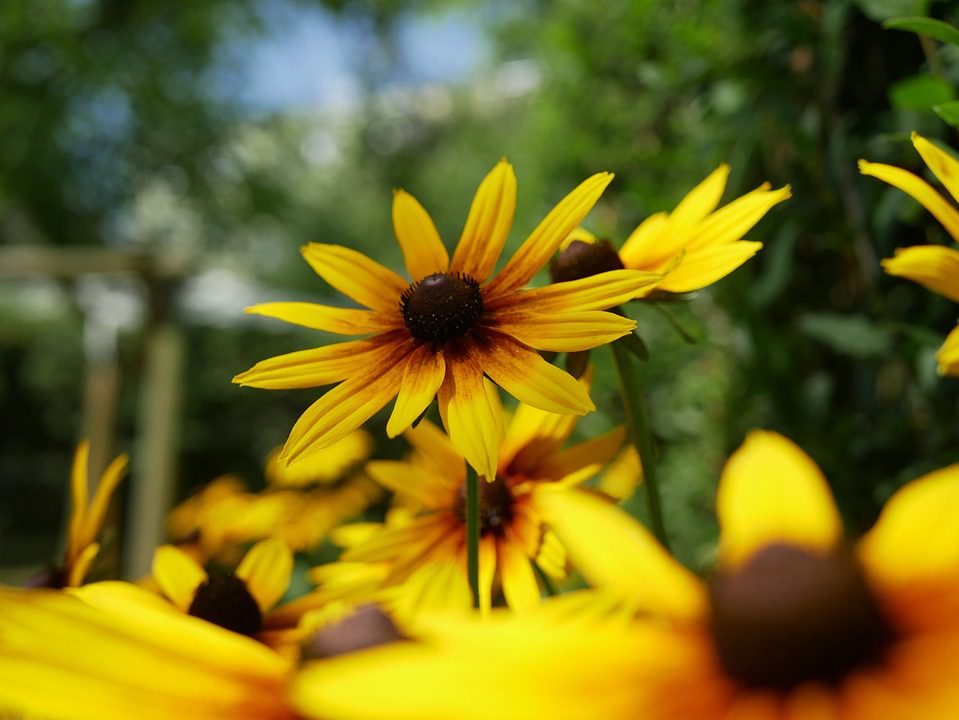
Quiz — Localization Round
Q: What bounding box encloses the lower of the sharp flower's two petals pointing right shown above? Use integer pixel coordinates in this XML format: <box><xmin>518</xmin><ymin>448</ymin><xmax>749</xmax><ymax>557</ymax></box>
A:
<box><xmin>496</xmin><ymin>310</ymin><xmax>636</xmax><ymax>352</ymax></box>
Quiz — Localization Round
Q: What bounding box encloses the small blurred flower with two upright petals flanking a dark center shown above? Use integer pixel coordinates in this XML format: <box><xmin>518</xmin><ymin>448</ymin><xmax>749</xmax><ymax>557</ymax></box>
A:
<box><xmin>153</xmin><ymin>539</ymin><xmax>293</xmax><ymax>636</ymax></box>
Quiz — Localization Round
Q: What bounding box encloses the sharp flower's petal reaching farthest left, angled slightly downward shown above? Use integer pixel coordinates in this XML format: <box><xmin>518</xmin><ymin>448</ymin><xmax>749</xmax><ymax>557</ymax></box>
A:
<box><xmin>233</xmin><ymin>333</ymin><xmax>407</xmax><ymax>390</ymax></box>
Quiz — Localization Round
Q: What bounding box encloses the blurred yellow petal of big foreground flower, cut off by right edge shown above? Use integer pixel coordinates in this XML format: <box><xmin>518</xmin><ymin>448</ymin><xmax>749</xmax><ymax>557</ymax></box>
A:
<box><xmin>859</xmin><ymin>465</ymin><xmax>959</xmax><ymax>582</ymax></box>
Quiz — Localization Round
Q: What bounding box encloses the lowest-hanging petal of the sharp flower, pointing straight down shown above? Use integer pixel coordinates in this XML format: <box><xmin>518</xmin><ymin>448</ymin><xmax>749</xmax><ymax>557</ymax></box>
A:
<box><xmin>439</xmin><ymin>355</ymin><xmax>502</xmax><ymax>480</ymax></box>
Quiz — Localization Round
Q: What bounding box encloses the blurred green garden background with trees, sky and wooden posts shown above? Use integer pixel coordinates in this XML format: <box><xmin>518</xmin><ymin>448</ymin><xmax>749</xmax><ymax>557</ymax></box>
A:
<box><xmin>0</xmin><ymin>0</ymin><xmax>959</xmax><ymax>582</ymax></box>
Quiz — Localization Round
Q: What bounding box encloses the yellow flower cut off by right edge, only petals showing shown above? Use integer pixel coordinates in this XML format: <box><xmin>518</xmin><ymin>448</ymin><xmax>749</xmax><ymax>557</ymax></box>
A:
<box><xmin>859</xmin><ymin>133</ymin><xmax>959</xmax><ymax>376</ymax></box>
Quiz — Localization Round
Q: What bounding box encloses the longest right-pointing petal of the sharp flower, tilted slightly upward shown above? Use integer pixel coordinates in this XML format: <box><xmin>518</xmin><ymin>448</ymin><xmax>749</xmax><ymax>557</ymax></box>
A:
<box><xmin>490</xmin><ymin>270</ymin><xmax>663</xmax><ymax>313</ymax></box>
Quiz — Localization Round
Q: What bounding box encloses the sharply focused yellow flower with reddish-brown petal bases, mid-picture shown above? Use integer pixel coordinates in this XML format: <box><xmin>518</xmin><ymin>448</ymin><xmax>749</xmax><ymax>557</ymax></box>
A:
<box><xmin>234</xmin><ymin>160</ymin><xmax>659</xmax><ymax>478</ymax></box>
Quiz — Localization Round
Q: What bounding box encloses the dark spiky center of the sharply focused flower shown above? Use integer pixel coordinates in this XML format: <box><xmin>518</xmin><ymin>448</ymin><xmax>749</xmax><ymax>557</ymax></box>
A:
<box><xmin>400</xmin><ymin>273</ymin><xmax>483</xmax><ymax>344</ymax></box>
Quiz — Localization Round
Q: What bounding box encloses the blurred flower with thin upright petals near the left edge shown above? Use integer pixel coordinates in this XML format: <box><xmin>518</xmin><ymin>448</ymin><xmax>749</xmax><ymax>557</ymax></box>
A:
<box><xmin>31</xmin><ymin>441</ymin><xmax>128</xmax><ymax>588</ymax></box>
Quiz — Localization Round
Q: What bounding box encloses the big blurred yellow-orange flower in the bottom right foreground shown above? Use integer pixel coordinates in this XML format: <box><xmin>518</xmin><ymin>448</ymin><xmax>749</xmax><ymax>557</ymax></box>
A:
<box><xmin>293</xmin><ymin>432</ymin><xmax>959</xmax><ymax>720</ymax></box>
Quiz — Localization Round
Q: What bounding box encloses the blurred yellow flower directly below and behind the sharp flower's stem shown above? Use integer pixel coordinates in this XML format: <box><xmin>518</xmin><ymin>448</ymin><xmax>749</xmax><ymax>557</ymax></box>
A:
<box><xmin>314</xmin><ymin>382</ymin><xmax>623</xmax><ymax>617</ymax></box>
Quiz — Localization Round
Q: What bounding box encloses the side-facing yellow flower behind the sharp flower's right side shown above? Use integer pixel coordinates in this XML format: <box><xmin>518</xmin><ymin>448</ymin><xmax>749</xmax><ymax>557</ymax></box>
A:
<box><xmin>550</xmin><ymin>164</ymin><xmax>791</xmax><ymax>297</ymax></box>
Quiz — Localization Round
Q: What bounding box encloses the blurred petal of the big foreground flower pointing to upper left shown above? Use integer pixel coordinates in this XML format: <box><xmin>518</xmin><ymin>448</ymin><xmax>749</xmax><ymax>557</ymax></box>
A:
<box><xmin>535</xmin><ymin>488</ymin><xmax>706</xmax><ymax>619</ymax></box>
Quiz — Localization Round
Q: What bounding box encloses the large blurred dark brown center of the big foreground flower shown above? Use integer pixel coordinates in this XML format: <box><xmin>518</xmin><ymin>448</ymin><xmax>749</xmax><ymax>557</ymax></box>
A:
<box><xmin>710</xmin><ymin>544</ymin><xmax>893</xmax><ymax>690</ymax></box>
